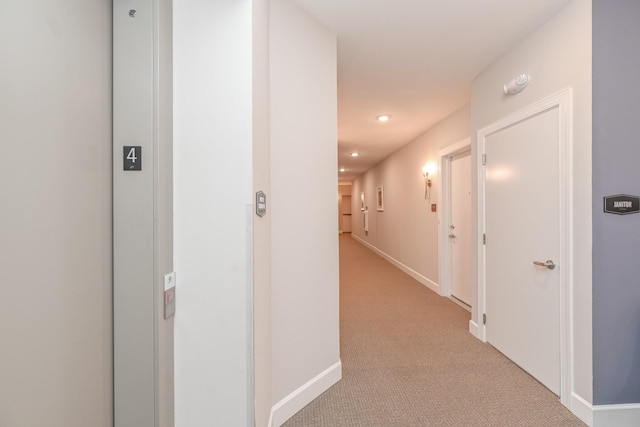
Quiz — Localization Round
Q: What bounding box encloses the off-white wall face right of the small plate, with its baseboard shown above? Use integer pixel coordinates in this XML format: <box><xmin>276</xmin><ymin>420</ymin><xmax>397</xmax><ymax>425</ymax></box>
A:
<box><xmin>270</xmin><ymin>0</ymin><xmax>341</xmax><ymax>425</ymax></box>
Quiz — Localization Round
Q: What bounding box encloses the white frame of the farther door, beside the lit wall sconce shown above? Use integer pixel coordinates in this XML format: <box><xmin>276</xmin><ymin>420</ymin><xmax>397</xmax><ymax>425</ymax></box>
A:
<box><xmin>438</xmin><ymin>138</ymin><xmax>471</xmax><ymax>304</ymax></box>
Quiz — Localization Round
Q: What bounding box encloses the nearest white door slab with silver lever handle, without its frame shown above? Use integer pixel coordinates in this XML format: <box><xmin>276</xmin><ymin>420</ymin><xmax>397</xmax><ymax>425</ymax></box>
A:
<box><xmin>485</xmin><ymin>108</ymin><xmax>563</xmax><ymax>394</ymax></box>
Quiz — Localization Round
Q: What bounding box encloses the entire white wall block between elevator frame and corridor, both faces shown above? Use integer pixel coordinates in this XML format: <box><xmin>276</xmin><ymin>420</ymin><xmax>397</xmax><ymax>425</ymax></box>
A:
<box><xmin>174</xmin><ymin>0</ymin><xmax>341</xmax><ymax>426</ymax></box>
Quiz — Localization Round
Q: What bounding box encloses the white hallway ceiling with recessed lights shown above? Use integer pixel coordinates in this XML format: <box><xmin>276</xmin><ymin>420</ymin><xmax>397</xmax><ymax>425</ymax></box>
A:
<box><xmin>293</xmin><ymin>0</ymin><xmax>571</xmax><ymax>182</ymax></box>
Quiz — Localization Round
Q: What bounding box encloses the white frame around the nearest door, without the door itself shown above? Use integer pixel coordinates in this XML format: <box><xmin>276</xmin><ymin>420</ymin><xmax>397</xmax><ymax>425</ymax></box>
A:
<box><xmin>472</xmin><ymin>88</ymin><xmax>574</xmax><ymax>407</ymax></box>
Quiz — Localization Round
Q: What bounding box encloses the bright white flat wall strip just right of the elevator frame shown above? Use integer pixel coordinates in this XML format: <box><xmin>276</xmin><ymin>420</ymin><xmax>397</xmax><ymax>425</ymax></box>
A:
<box><xmin>174</xmin><ymin>0</ymin><xmax>253</xmax><ymax>427</ymax></box>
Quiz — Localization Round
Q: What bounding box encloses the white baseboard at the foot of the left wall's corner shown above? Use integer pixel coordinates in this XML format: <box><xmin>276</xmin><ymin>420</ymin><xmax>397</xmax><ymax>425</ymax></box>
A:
<box><xmin>269</xmin><ymin>361</ymin><xmax>342</xmax><ymax>427</ymax></box>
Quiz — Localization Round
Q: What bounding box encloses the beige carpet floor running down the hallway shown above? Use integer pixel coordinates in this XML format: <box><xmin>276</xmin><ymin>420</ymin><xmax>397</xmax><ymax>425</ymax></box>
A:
<box><xmin>284</xmin><ymin>234</ymin><xmax>585</xmax><ymax>427</ymax></box>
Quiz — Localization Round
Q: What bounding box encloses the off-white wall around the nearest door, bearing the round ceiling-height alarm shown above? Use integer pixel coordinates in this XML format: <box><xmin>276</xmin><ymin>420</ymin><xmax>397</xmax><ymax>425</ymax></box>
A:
<box><xmin>471</xmin><ymin>0</ymin><xmax>592</xmax><ymax>408</ymax></box>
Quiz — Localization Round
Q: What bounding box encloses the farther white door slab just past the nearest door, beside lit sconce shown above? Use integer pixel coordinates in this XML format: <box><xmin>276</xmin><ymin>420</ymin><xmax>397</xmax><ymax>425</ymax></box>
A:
<box><xmin>449</xmin><ymin>152</ymin><xmax>472</xmax><ymax>306</ymax></box>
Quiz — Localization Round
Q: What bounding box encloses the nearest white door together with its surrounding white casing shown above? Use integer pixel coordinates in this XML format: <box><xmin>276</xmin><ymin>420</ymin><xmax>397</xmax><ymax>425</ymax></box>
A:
<box><xmin>477</xmin><ymin>89</ymin><xmax>572</xmax><ymax>406</ymax></box>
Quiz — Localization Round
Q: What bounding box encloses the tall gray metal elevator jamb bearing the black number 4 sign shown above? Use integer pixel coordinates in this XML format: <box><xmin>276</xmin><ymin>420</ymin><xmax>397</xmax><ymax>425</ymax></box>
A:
<box><xmin>113</xmin><ymin>0</ymin><xmax>169</xmax><ymax>427</ymax></box>
